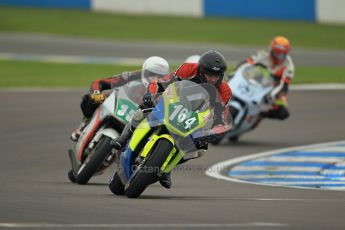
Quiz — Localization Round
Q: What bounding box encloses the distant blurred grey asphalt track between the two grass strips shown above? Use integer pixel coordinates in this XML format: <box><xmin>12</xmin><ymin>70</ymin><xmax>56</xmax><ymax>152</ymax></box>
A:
<box><xmin>0</xmin><ymin>32</ymin><xmax>345</xmax><ymax>67</ymax></box>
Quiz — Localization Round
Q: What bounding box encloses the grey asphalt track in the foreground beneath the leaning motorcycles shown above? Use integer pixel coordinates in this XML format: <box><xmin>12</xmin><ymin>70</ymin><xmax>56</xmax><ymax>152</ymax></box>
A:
<box><xmin>0</xmin><ymin>33</ymin><xmax>345</xmax><ymax>229</ymax></box>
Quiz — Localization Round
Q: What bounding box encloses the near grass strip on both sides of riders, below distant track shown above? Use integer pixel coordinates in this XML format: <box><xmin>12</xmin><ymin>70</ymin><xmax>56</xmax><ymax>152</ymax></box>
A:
<box><xmin>0</xmin><ymin>61</ymin><xmax>345</xmax><ymax>88</ymax></box>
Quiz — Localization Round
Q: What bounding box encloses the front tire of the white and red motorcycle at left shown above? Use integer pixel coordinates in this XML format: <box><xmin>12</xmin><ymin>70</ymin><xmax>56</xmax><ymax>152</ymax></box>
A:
<box><xmin>75</xmin><ymin>136</ymin><xmax>112</xmax><ymax>185</ymax></box>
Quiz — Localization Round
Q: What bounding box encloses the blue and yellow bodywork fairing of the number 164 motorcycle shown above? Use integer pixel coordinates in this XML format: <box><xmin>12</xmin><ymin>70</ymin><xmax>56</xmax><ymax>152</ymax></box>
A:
<box><xmin>118</xmin><ymin>82</ymin><xmax>213</xmax><ymax>184</ymax></box>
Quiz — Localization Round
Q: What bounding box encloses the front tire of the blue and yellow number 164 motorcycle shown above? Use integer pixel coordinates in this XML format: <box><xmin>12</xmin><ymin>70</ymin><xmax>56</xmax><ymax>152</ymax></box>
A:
<box><xmin>125</xmin><ymin>139</ymin><xmax>173</xmax><ymax>198</ymax></box>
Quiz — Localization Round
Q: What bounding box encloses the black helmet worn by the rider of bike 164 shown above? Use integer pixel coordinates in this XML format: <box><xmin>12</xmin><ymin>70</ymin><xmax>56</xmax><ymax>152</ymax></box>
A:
<box><xmin>198</xmin><ymin>50</ymin><xmax>228</xmax><ymax>88</ymax></box>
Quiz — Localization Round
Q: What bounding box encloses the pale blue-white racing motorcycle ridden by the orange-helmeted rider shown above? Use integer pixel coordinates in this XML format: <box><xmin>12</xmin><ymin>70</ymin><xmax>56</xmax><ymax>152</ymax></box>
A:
<box><xmin>212</xmin><ymin>64</ymin><xmax>273</xmax><ymax>144</ymax></box>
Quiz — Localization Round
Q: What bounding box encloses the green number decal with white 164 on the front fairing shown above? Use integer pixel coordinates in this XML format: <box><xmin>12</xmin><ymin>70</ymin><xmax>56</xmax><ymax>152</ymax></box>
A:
<box><xmin>169</xmin><ymin>103</ymin><xmax>199</xmax><ymax>132</ymax></box>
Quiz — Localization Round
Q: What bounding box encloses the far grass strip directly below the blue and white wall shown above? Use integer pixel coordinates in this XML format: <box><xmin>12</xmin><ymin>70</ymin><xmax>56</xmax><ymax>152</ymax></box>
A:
<box><xmin>0</xmin><ymin>7</ymin><xmax>345</xmax><ymax>49</ymax></box>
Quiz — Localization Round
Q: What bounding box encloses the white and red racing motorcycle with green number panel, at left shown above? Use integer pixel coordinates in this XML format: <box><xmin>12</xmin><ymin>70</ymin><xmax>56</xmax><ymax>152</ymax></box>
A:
<box><xmin>68</xmin><ymin>81</ymin><xmax>145</xmax><ymax>184</ymax></box>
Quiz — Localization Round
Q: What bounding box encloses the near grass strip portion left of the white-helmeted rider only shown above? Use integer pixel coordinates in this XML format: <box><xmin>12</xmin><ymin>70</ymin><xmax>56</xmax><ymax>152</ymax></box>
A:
<box><xmin>0</xmin><ymin>61</ymin><xmax>140</xmax><ymax>88</ymax></box>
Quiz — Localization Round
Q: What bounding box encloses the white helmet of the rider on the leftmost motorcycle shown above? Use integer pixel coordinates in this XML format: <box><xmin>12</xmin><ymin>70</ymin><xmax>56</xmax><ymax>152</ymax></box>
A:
<box><xmin>141</xmin><ymin>56</ymin><xmax>169</xmax><ymax>87</ymax></box>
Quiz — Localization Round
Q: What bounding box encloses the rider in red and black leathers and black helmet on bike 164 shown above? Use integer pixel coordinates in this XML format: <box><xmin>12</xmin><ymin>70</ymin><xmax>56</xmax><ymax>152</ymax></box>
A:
<box><xmin>112</xmin><ymin>50</ymin><xmax>232</xmax><ymax>188</ymax></box>
